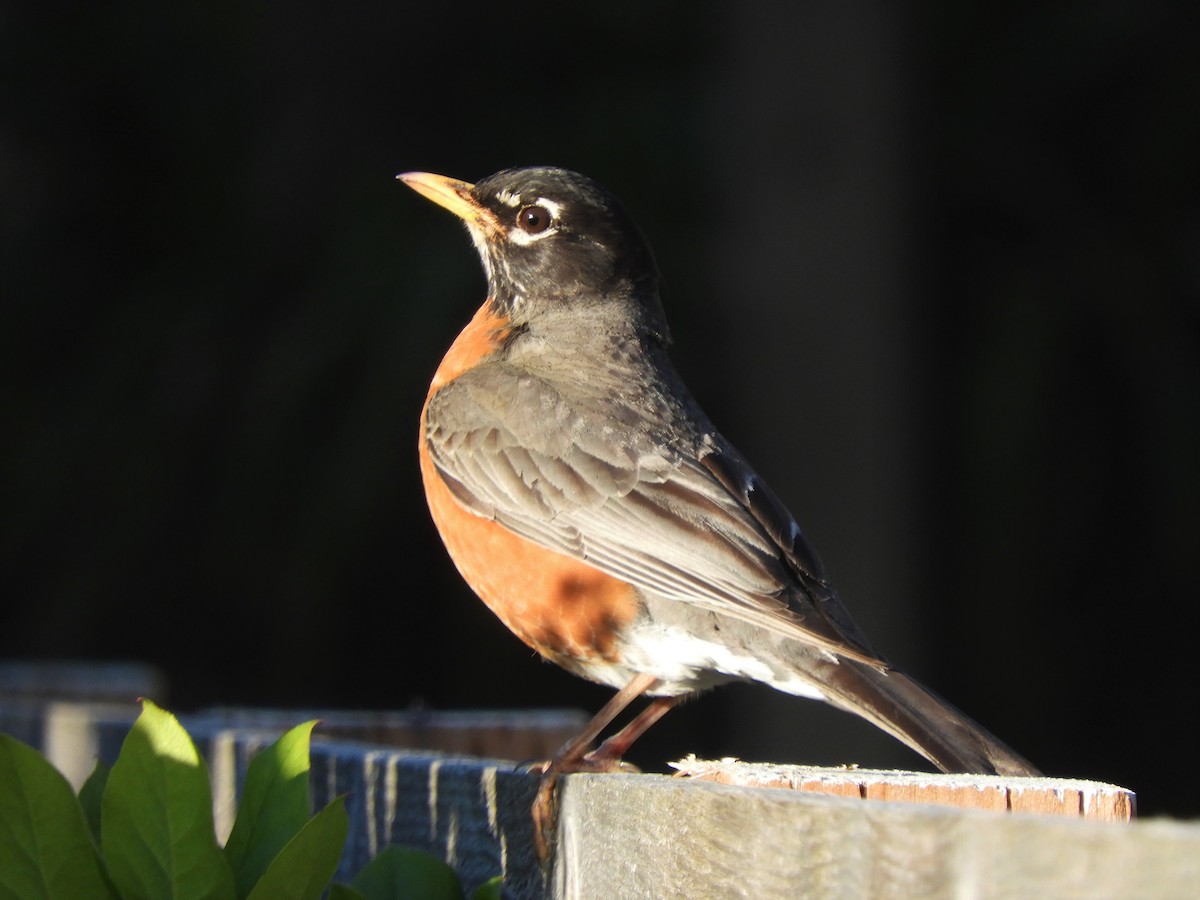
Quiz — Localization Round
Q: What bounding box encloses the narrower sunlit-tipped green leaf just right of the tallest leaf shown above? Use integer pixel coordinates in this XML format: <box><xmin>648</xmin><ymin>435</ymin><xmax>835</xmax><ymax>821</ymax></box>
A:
<box><xmin>224</xmin><ymin>721</ymin><xmax>317</xmax><ymax>896</ymax></box>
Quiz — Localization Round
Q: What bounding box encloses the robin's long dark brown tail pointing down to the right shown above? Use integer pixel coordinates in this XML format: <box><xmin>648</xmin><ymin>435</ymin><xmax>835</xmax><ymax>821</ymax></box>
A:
<box><xmin>823</xmin><ymin>659</ymin><xmax>1042</xmax><ymax>776</ymax></box>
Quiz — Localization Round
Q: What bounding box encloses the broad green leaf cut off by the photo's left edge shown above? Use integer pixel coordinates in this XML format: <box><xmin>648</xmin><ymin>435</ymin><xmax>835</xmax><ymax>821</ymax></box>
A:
<box><xmin>0</xmin><ymin>734</ymin><xmax>115</xmax><ymax>900</ymax></box>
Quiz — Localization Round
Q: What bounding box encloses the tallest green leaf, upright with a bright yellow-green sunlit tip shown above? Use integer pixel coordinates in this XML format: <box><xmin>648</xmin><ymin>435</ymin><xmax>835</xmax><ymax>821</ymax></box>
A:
<box><xmin>100</xmin><ymin>701</ymin><xmax>235</xmax><ymax>900</ymax></box>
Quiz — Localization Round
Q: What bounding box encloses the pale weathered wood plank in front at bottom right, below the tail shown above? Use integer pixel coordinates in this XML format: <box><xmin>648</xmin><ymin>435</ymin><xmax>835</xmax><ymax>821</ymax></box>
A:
<box><xmin>554</xmin><ymin>775</ymin><xmax>1200</xmax><ymax>899</ymax></box>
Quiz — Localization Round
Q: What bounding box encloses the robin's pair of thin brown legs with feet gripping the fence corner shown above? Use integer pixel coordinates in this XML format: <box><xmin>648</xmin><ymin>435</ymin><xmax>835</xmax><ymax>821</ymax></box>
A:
<box><xmin>533</xmin><ymin>674</ymin><xmax>671</xmax><ymax>863</ymax></box>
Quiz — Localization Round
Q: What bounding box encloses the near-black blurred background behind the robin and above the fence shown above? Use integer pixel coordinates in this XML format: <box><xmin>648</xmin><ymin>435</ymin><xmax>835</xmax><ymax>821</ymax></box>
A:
<box><xmin>0</xmin><ymin>0</ymin><xmax>1200</xmax><ymax>816</ymax></box>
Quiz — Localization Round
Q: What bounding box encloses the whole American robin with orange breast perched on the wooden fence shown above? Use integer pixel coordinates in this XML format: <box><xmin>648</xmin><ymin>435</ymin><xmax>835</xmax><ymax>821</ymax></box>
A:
<box><xmin>398</xmin><ymin>167</ymin><xmax>1037</xmax><ymax>854</ymax></box>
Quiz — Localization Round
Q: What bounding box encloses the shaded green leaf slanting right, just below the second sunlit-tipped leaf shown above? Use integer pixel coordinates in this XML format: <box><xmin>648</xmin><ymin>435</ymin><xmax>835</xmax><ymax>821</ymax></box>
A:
<box><xmin>243</xmin><ymin>797</ymin><xmax>349</xmax><ymax>900</ymax></box>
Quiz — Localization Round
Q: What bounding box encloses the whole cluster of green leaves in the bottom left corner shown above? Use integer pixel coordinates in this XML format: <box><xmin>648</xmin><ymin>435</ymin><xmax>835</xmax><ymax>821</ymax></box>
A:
<box><xmin>0</xmin><ymin>701</ymin><xmax>500</xmax><ymax>900</ymax></box>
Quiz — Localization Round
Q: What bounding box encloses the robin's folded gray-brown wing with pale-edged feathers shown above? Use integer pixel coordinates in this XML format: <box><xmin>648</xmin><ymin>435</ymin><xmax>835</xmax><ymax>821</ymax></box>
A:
<box><xmin>426</xmin><ymin>367</ymin><xmax>874</xmax><ymax>659</ymax></box>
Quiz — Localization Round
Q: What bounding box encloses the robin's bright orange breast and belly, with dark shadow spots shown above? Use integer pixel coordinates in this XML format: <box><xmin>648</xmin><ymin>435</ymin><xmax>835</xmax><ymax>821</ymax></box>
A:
<box><xmin>419</xmin><ymin>301</ymin><xmax>640</xmax><ymax>674</ymax></box>
